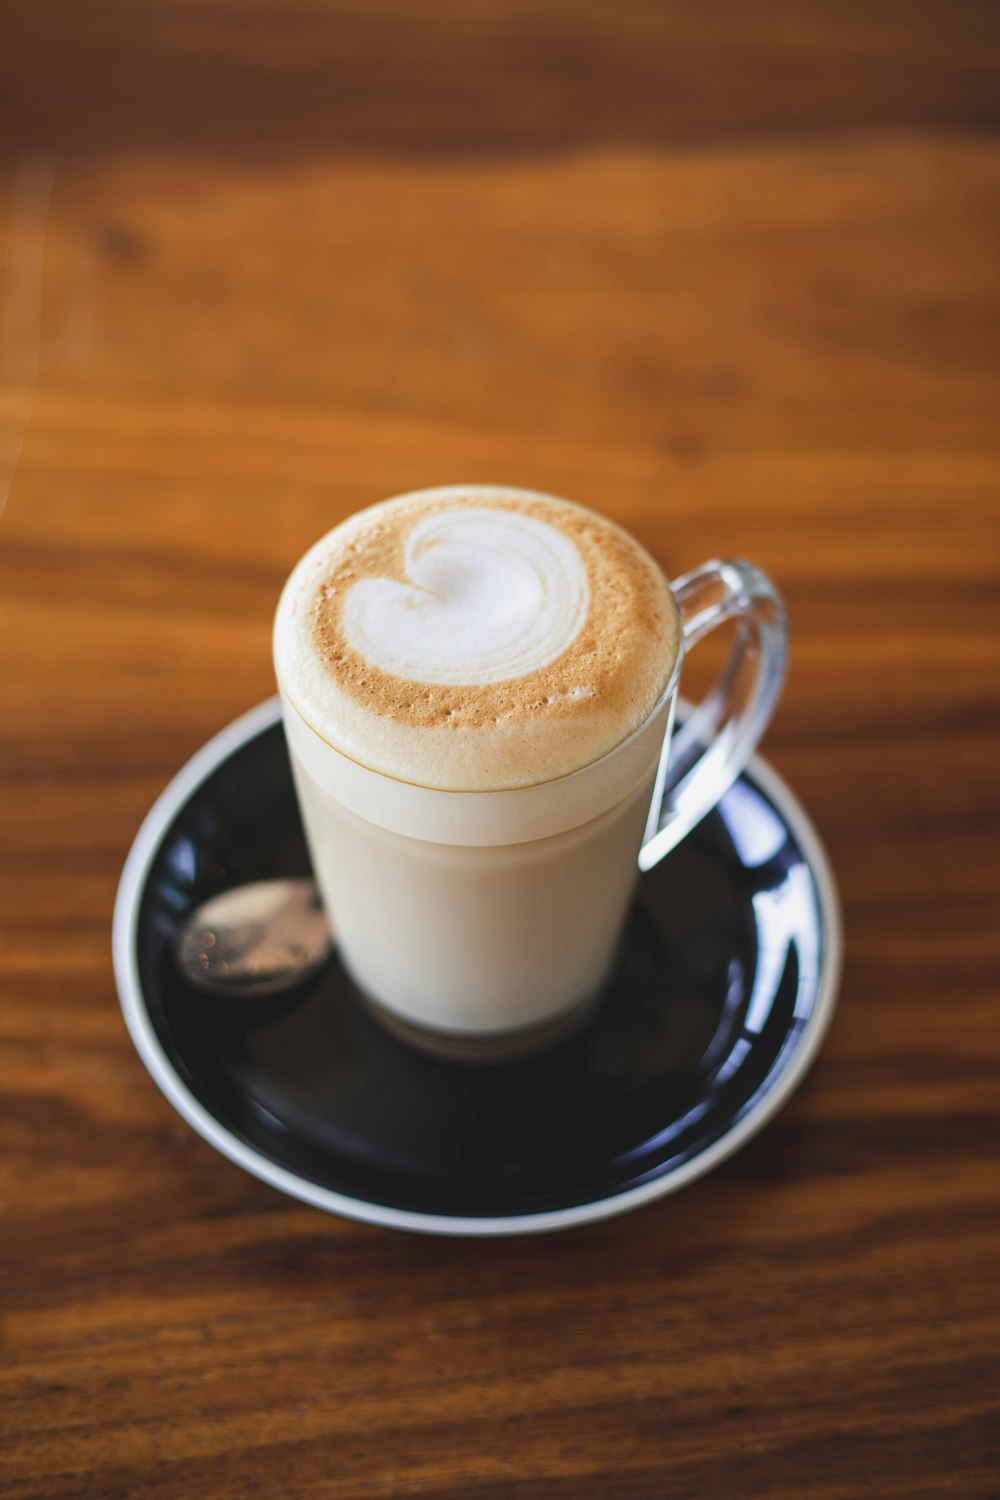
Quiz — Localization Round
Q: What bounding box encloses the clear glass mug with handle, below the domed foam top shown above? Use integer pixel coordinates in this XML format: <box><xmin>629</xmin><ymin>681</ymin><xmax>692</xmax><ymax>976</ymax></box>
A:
<box><xmin>279</xmin><ymin>561</ymin><xmax>787</xmax><ymax>1061</ymax></box>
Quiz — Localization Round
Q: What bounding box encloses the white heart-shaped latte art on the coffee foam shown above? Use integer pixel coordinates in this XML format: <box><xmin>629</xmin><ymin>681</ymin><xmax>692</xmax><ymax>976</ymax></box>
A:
<box><xmin>343</xmin><ymin>507</ymin><xmax>591</xmax><ymax>687</ymax></box>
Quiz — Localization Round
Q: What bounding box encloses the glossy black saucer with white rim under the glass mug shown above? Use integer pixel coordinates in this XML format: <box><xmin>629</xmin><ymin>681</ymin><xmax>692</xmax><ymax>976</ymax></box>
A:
<box><xmin>115</xmin><ymin>701</ymin><xmax>840</xmax><ymax>1235</ymax></box>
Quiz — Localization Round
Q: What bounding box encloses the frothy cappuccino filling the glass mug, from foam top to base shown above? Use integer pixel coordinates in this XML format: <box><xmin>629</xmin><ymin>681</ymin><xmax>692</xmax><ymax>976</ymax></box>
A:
<box><xmin>274</xmin><ymin>486</ymin><xmax>681</xmax><ymax>1055</ymax></box>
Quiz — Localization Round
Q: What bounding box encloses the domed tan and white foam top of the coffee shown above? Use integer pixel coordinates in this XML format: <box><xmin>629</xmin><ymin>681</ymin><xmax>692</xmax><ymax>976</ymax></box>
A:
<box><xmin>274</xmin><ymin>486</ymin><xmax>679</xmax><ymax>792</ymax></box>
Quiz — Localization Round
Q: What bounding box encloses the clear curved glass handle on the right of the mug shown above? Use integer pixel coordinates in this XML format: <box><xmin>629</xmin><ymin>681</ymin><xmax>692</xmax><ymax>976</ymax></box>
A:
<box><xmin>639</xmin><ymin>560</ymin><xmax>789</xmax><ymax>870</ymax></box>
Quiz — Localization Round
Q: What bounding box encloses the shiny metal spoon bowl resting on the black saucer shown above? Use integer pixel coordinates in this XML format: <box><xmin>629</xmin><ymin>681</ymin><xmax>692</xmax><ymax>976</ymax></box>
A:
<box><xmin>174</xmin><ymin>881</ymin><xmax>333</xmax><ymax>999</ymax></box>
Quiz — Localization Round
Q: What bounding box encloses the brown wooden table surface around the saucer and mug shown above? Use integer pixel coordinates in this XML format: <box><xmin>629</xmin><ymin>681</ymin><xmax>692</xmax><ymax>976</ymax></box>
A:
<box><xmin>0</xmin><ymin>0</ymin><xmax>1000</xmax><ymax>1500</ymax></box>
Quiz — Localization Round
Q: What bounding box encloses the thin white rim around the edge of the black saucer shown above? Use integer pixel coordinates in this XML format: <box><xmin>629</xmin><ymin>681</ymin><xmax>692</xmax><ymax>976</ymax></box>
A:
<box><xmin>112</xmin><ymin>698</ymin><xmax>843</xmax><ymax>1238</ymax></box>
